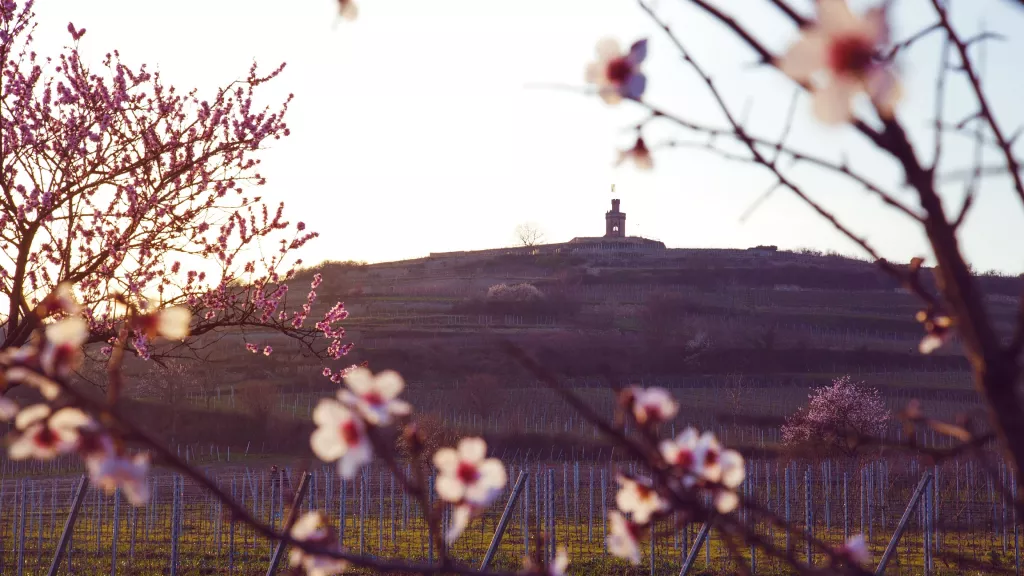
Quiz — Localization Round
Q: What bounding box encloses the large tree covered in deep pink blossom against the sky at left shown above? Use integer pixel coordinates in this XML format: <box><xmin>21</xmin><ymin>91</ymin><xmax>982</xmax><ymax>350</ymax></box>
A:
<box><xmin>0</xmin><ymin>2</ymin><xmax>347</xmax><ymax>373</ymax></box>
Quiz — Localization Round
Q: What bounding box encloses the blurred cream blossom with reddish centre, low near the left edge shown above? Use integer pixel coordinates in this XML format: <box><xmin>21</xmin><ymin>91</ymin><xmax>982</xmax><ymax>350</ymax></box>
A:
<box><xmin>7</xmin><ymin>404</ymin><xmax>91</xmax><ymax>460</ymax></box>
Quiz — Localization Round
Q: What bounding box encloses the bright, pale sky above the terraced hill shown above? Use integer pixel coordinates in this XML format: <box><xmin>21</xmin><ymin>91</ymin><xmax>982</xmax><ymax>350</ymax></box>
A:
<box><xmin>19</xmin><ymin>0</ymin><xmax>1024</xmax><ymax>274</ymax></box>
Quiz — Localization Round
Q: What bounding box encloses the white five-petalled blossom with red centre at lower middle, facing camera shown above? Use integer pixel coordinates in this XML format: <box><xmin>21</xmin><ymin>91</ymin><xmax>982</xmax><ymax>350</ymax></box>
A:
<box><xmin>434</xmin><ymin>438</ymin><xmax>508</xmax><ymax>506</ymax></box>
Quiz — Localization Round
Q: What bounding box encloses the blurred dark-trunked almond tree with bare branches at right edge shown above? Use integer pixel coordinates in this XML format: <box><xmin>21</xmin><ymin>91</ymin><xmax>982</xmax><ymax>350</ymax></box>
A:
<box><xmin>585</xmin><ymin>0</ymin><xmax>1024</xmax><ymax>498</ymax></box>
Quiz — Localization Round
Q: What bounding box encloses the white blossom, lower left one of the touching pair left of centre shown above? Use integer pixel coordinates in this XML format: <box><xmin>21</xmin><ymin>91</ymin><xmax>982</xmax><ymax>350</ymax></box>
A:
<box><xmin>309</xmin><ymin>398</ymin><xmax>374</xmax><ymax>479</ymax></box>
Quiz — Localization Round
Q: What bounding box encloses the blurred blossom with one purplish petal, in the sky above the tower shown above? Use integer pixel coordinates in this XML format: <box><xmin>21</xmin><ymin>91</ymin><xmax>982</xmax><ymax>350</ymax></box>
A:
<box><xmin>586</xmin><ymin>38</ymin><xmax>647</xmax><ymax>105</ymax></box>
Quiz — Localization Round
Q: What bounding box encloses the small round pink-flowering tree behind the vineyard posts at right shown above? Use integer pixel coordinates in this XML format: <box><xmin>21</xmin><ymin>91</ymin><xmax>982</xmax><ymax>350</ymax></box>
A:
<box><xmin>782</xmin><ymin>375</ymin><xmax>890</xmax><ymax>456</ymax></box>
